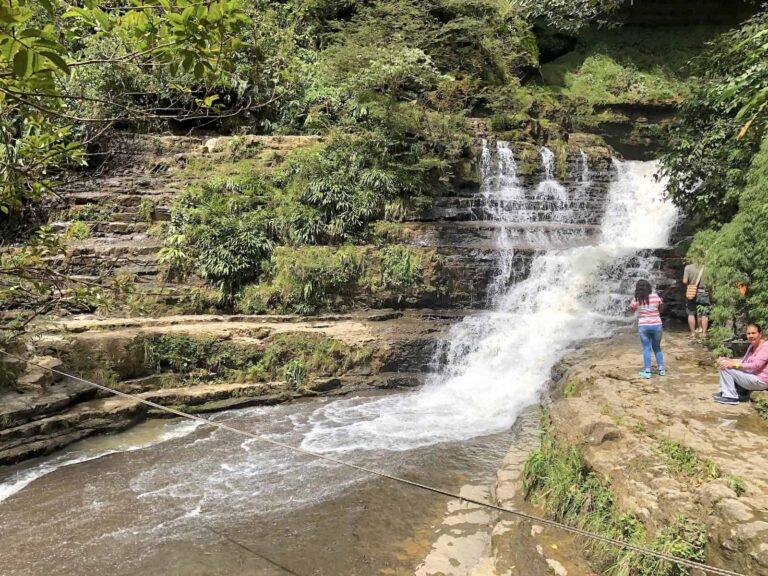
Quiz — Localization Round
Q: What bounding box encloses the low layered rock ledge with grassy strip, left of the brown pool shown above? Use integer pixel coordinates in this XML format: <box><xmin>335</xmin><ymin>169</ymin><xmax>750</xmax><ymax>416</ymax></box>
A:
<box><xmin>0</xmin><ymin>310</ymin><xmax>462</xmax><ymax>464</ymax></box>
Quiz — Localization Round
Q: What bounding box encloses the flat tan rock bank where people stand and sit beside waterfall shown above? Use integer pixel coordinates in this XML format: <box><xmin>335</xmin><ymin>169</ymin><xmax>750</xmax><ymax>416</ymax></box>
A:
<box><xmin>494</xmin><ymin>331</ymin><xmax>768</xmax><ymax>575</ymax></box>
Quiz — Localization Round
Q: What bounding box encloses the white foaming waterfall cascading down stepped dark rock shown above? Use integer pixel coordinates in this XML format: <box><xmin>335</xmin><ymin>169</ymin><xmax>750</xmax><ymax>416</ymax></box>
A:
<box><xmin>302</xmin><ymin>142</ymin><xmax>676</xmax><ymax>451</ymax></box>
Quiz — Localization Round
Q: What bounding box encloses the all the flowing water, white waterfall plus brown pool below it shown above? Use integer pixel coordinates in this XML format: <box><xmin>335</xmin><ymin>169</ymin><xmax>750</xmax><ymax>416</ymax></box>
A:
<box><xmin>0</xmin><ymin>142</ymin><xmax>675</xmax><ymax>576</ymax></box>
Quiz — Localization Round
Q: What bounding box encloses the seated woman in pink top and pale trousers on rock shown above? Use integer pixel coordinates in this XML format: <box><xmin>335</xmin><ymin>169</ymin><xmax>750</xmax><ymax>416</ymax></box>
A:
<box><xmin>712</xmin><ymin>324</ymin><xmax>768</xmax><ymax>404</ymax></box>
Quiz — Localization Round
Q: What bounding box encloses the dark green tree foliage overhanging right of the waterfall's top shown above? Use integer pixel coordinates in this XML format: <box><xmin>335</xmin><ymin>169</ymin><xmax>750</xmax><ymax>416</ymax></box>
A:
<box><xmin>662</xmin><ymin>11</ymin><xmax>768</xmax><ymax>226</ymax></box>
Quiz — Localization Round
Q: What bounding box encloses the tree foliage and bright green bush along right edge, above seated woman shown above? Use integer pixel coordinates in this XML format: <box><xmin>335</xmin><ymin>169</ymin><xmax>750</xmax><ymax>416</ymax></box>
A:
<box><xmin>648</xmin><ymin>9</ymin><xmax>768</xmax><ymax>354</ymax></box>
